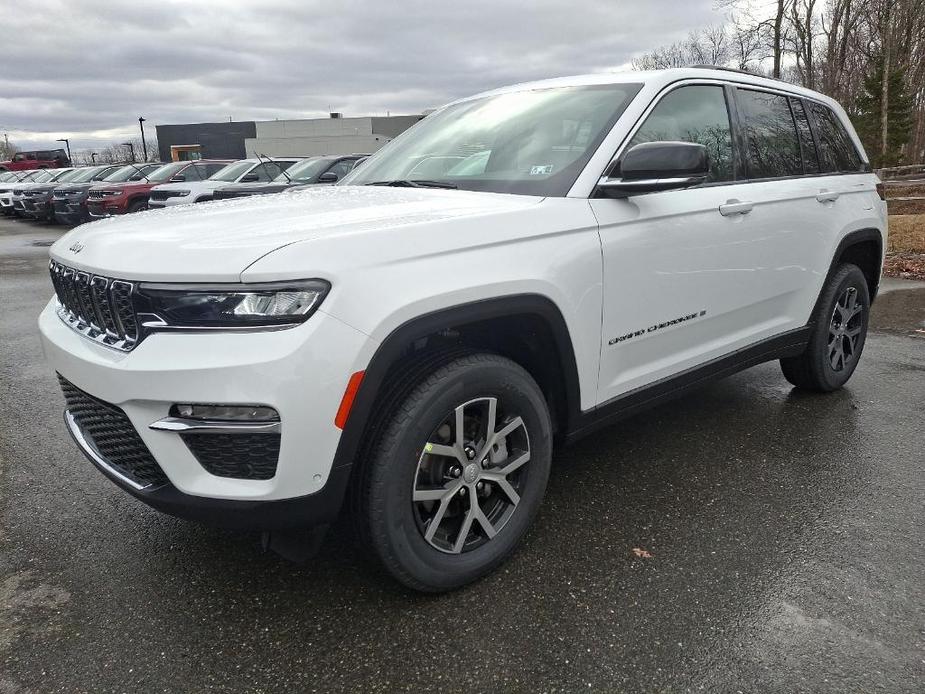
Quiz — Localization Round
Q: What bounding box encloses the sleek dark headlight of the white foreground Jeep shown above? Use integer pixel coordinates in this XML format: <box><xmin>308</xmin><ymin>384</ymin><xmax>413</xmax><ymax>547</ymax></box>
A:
<box><xmin>135</xmin><ymin>280</ymin><xmax>331</xmax><ymax>330</ymax></box>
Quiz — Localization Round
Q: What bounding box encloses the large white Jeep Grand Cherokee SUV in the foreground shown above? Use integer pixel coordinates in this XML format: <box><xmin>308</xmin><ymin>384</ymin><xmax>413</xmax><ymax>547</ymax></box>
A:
<box><xmin>39</xmin><ymin>68</ymin><xmax>887</xmax><ymax>591</ymax></box>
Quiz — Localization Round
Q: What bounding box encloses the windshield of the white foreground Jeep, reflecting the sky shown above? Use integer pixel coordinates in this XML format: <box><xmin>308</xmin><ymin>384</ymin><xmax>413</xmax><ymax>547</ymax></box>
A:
<box><xmin>342</xmin><ymin>84</ymin><xmax>641</xmax><ymax>196</ymax></box>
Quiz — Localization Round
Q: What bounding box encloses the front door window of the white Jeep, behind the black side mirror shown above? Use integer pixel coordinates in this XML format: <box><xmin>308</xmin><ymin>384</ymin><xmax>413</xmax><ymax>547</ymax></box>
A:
<box><xmin>629</xmin><ymin>86</ymin><xmax>735</xmax><ymax>181</ymax></box>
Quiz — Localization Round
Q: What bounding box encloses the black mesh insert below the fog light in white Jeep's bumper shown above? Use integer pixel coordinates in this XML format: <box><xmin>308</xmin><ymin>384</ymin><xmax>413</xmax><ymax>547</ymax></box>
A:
<box><xmin>180</xmin><ymin>433</ymin><xmax>280</xmax><ymax>480</ymax></box>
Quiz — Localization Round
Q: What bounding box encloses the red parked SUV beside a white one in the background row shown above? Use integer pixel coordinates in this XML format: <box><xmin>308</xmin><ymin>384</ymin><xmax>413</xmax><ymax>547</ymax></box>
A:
<box><xmin>87</xmin><ymin>159</ymin><xmax>231</xmax><ymax>219</ymax></box>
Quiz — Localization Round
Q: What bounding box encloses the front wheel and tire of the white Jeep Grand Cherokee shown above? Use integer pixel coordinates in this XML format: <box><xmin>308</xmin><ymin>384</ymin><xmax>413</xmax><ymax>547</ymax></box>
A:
<box><xmin>355</xmin><ymin>354</ymin><xmax>552</xmax><ymax>593</ymax></box>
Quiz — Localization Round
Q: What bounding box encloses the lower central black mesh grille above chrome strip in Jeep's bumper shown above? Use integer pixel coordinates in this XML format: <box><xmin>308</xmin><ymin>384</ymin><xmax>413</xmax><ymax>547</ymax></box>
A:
<box><xmin>58</xmin><ymin>374</ymin><xmax>168</xmax><ymax>487</ymax></box>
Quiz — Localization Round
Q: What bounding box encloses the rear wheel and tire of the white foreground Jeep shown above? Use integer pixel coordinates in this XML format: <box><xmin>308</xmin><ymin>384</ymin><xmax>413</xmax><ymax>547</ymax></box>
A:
<box><xmin>780</xmin><ymin>263</ymin><xmax>870</xmax><ymax>393</ymax></box>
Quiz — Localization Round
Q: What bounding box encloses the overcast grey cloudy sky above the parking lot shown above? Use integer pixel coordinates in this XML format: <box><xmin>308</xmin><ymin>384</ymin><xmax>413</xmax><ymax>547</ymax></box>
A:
<box><xmin>0</xmin><ymin>0</ymin><xmax>721</xmax><ymax>155</ymax></box>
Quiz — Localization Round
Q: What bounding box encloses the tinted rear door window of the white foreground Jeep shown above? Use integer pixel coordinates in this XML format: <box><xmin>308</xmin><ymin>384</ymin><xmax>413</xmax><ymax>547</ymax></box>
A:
<box><xmin>737</xmin><ymin>89</ymin><xmax>803</xmax><ymax>178</ymax></box>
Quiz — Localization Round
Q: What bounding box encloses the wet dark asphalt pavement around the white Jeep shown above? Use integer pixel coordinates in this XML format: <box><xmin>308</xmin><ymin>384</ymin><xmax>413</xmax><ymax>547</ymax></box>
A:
<box><xmin>0</xmin><ymin>220</ymin><xmax>925</xmax><ymax>694</ymax></box>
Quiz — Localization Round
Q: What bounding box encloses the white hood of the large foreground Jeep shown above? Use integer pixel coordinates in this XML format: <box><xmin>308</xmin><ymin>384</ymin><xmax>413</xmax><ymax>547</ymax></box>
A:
<box><xmin>51</xmin><ymin>186</ymin><xmax>541</xmax><ymax>282</ymax></box>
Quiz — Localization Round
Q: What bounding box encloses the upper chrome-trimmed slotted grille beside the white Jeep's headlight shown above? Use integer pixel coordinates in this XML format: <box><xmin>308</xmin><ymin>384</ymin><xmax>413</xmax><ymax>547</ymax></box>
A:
<box><xmin>49</xmin><ymin>260</ymin><xmax>138</xmax><ymax>352</ymax></box>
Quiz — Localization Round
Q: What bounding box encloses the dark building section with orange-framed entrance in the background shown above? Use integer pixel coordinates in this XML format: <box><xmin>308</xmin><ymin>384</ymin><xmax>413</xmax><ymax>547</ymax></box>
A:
<box><xmin>155</xmin><ymin>121</ymin><xmax>257</xmax><ymax>161</ymax></box>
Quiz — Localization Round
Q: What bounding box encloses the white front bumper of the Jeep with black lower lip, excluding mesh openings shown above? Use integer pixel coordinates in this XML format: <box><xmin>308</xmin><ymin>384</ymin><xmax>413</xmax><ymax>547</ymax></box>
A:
<box><xmin>39</xmin><ymin>299</ymin><xmax>374</xmax><ymax>529</ymax></box>
